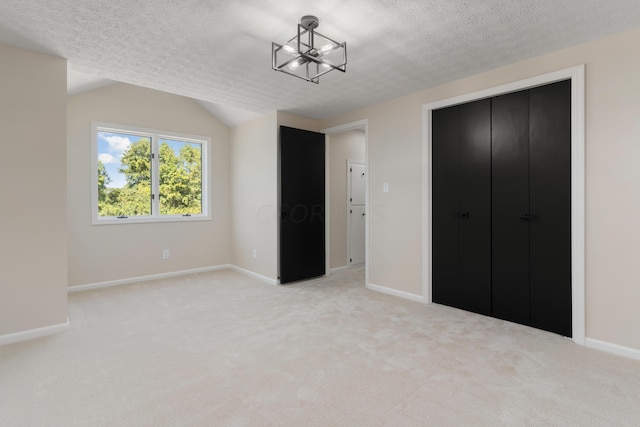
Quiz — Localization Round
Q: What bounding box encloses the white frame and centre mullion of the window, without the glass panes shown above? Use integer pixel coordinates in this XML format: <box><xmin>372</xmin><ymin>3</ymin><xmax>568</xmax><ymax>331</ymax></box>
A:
<box><xmin>91</xmin><ymin>121</ymin><xmax>211</xmax><ymax>225</ymax></box>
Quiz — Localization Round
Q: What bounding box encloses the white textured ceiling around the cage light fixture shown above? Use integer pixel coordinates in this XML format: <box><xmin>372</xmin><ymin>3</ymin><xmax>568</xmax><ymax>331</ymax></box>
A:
<box><xmin>0</xmin><ymin>0</ymin><xmax>640</xmax><ymax>125</ymax></box>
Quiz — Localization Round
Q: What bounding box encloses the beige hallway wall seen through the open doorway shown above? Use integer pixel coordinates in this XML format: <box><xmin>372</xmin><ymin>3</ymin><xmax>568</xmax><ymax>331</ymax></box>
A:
<box><xmin>329</xmin><ymin>130</ymin><xmax>365</xmax><ymax>268</ymax></box>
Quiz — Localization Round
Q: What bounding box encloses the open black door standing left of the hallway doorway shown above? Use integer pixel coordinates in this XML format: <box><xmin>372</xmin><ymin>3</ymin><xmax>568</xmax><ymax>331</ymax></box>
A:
<box><xmin>279</xmin><ymin>126</ymin><xmax>325</xmax><ymax>283</ymax></box>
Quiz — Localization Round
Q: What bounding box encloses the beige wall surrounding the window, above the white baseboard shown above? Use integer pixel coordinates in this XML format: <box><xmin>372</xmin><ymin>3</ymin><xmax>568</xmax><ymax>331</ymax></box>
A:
<box><xmin>67</xmin><ymin>84</ymin><xmax>230</xmax><ymax>286</ymax></box>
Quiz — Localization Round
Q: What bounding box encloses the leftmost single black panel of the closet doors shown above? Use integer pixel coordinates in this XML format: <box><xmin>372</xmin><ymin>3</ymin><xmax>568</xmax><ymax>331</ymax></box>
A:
<box><xmin>431</xmin><ymin>107</ymin><xmax>459</xmax><ymax>307</ymax></box>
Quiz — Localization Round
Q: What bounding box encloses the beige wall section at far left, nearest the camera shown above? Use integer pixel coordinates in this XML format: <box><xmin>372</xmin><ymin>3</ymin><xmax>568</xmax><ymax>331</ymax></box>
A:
<box><xmin>0</xmin><ymin>44</ymin><xmax>67</xmax><ymax>335</ymax></box>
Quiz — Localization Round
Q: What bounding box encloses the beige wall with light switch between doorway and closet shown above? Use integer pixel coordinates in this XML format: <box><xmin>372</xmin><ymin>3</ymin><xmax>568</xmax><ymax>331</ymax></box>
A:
<box><xmin>323</xmin><ymin>95</ymin><xmax>422</xmax><ymax>295</ymax></box>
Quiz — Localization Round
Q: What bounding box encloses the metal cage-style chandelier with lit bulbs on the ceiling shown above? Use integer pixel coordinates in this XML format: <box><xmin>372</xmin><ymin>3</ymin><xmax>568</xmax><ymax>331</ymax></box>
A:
<box><xmin>271</xmin><ymin>15</ymin><xmax>347</xmax><ymax>84</ymax></box>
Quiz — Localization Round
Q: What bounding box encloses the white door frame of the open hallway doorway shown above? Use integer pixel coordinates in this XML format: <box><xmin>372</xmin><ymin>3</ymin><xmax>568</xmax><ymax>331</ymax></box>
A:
<box><xmin>320</xmin><ymin>119</ymin><xmax>369</xmax><ymax>285</ymax></box>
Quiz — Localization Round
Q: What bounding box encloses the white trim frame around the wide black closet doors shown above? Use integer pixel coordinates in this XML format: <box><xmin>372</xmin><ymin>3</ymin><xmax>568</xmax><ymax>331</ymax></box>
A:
<box><xmin>422</xmin><ymin>65</ymin><xmax>585</xmax><ymax>345</ymax></box>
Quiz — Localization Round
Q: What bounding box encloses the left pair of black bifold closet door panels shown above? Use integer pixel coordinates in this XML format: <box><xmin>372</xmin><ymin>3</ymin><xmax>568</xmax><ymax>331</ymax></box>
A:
<box><xmin>432</xmin><ymin>100</ymin><xmax>491</xmax><ymax>314</ymax></box>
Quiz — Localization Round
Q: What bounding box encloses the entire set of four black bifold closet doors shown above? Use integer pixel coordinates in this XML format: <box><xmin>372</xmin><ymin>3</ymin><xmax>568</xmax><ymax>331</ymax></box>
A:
<box><xmin>432</xmin><ymin>80</ymin><xmax>572</xmax><ymax>336</ymax></box>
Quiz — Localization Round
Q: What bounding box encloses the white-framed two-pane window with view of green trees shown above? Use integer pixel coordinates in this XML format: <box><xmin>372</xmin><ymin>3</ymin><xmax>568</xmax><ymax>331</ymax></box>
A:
<box><xmin>92</xmin><ymin>122</ymin><xmax>210</xmax><ymax>224</ymax></box>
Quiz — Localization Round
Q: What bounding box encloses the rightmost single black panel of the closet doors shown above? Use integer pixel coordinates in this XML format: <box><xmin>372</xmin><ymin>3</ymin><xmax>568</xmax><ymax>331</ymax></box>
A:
<box><xmin>530</xmin><ymin>80</ymin><xmax>571</xmax><ymax>336</ymax></box>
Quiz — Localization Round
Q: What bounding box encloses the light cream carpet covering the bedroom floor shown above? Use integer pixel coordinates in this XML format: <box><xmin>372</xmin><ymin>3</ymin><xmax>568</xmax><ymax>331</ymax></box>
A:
<box><xmin>0</xmin><ymin>269</ymin><xmax>640</xmax><ymax>426</ymax></box>
